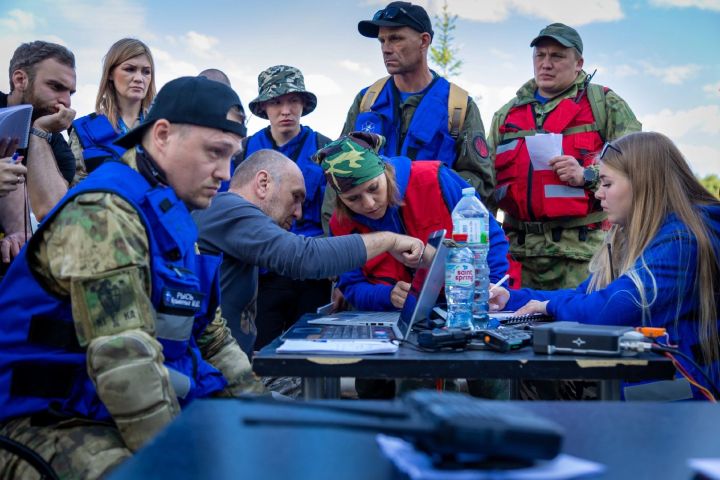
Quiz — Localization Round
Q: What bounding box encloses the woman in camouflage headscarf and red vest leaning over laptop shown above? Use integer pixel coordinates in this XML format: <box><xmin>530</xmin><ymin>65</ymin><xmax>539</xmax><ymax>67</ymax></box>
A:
<box><xmin>317</xmin><ymin>132</ymin><xmax>508</xmax><ymax>310</ymax></box>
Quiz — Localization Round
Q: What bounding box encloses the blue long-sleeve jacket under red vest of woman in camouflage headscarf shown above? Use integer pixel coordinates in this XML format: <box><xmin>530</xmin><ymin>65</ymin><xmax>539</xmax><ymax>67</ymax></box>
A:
<box><xmin>338</xmin><ymin>157</ymin><xmax>509</xmax><ymax>311</ymax></box>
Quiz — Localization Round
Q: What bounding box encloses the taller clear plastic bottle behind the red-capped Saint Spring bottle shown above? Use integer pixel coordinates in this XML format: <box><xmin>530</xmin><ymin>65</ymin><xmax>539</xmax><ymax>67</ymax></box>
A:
<box><xmin>452</xmin><ymin>187</ymin><xmax>490</xmax><ymax>328</ymax></box>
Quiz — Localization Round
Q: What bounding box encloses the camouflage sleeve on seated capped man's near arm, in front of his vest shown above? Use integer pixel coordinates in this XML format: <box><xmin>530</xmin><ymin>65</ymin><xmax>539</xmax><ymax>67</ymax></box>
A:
<box><xmin>30</xmin><ymin>193</ymin><xmax>180</xmax><ymax>450</ymax></box>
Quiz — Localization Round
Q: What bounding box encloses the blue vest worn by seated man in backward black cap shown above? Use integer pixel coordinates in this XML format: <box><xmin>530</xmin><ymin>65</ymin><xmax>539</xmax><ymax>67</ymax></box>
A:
<box><xmin>0</xmin><ymin>162</ymin><xmax>227</xmax><ymax>421</ymax></box>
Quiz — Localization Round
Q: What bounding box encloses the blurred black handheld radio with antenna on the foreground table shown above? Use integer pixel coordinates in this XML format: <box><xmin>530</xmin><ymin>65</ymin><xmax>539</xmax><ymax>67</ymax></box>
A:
<box><xmin>243</xmin><ymin>390</ymin><xmax>563</xmax><ymax>467</ymax></box>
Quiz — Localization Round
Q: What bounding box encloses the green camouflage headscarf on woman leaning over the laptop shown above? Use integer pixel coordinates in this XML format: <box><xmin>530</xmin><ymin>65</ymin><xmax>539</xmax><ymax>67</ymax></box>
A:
<box><xmin>315</xmin><ymin>132</ymin><xmax>385</xmax><ymax>193</ymax></box>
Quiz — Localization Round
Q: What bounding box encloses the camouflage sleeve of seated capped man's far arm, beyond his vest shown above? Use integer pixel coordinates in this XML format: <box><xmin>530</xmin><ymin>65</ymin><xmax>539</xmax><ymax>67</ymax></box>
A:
<box><xmin>198</xmin><ymin>307</ymin><xmax>265</xmax><ymax>396</ymax></box>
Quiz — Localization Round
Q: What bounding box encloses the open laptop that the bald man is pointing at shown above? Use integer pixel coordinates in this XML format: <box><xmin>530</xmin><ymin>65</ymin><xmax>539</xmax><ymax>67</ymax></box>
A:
<box><xmin>281</xmin><ymin>230</ymin><xmax>447</xmax><ymax>341</ymax></box>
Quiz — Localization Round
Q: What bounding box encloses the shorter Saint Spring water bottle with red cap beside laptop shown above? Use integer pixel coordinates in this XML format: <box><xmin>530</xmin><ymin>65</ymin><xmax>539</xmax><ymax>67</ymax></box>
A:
<box><xmin>445</xmin><ymin>233</ymin><xmax>475</xmax><ymax>329</ymax></box>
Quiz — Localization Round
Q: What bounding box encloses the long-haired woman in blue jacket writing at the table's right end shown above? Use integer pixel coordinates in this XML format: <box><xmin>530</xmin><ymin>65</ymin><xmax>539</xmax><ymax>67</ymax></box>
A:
<box><xmin>490</xmin><ymin>132</ymin><xmax>720</xmax><ymax>399</ymax></box>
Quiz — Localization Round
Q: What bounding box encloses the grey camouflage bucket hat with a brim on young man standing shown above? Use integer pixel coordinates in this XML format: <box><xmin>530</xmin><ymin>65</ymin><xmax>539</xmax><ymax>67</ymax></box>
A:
<box><xmin>249</xmin><ymin>65</ymin><xmax>317</xmax><ymax>120</ymax></box>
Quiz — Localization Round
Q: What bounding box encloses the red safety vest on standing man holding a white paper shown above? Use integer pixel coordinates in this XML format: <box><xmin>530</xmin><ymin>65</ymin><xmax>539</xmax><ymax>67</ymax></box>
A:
<box><xmin>495</xmin><ymin>95</ymin><xmax>603</xmax><ymax>221</ymax></box>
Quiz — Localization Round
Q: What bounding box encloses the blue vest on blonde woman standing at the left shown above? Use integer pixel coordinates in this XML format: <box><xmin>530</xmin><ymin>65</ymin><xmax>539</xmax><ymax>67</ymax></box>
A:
<box><xmin>73</xmin><ymin>113</ymin><xmax>126</xmax><ymax>173</ymax></box>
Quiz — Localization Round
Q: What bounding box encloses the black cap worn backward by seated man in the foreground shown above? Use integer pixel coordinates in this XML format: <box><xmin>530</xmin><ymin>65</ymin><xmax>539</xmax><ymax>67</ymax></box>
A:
<box><xmin>114</xmin><ymin>77</ymin><xmax>247</xmax><ymax>148</ymax></box>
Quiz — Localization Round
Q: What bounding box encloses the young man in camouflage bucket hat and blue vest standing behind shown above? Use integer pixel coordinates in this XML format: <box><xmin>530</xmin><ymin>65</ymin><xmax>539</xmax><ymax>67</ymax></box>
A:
<box><xmin>234</xmin><ymin>65</ymin><xmax>331</xmax><ymax>355</ymax></box>
